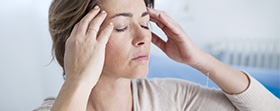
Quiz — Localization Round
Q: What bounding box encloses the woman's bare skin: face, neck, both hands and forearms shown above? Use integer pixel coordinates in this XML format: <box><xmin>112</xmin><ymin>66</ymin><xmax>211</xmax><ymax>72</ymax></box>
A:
<box><xmin>52</xmin><ymin>0</ymin><xmax>249</xmax><ymax>111</ymax></box>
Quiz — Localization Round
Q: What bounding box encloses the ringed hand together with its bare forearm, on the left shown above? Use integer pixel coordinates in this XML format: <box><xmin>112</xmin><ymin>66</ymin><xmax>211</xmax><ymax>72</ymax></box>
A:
<box><xmin>52</xmin><ymin>5</ymin><xmax>114</xmax><ymax>111</ymax></box>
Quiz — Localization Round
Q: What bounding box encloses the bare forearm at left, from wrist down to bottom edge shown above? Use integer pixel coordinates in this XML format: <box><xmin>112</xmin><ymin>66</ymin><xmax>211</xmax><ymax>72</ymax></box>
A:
<box><xmin>52</xmin><ymin>79</ymin><xmax>92</xmax><ymax>111</ymax></box>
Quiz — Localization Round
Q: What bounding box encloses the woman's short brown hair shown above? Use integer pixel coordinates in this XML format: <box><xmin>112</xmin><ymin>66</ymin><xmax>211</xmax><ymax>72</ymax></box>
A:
<box><xmin>49</xmin><ymin>0</ymin><xmax>154</xmax><ymax>76</ymax></box>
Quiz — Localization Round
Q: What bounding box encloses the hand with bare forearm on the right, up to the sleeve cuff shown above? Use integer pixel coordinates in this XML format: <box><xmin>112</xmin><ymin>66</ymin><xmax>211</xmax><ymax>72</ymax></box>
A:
<box><xmin>148</xmin><ymin>8</ymin><xmax>252</xmax><ymax>94</ymax></box>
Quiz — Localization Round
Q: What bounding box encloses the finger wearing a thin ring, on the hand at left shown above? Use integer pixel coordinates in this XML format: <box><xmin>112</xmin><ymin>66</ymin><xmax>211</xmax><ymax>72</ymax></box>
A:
<box><xmin>86</xmin><ymin>10</ymin><xmax>107</xmax><ymax>37</ymax></box>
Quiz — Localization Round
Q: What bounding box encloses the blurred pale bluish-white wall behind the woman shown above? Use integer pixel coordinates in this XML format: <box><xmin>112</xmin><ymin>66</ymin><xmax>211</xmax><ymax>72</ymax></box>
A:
<box><xmin>0</xmin><ymin>0</ymin><xmax>280</xmax><ymax>111</ymax></box>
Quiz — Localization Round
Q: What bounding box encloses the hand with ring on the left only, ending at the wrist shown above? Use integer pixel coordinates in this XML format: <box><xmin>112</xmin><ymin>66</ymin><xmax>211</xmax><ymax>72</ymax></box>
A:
<box><xmin>64</xmin><ymin>6</ymin><xmax>114</xmax><ymax>87</ymax></box>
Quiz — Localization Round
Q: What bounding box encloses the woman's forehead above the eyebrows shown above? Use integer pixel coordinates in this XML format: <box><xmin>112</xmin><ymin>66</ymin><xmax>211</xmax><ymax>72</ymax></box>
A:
<box><xmin>101</xmin><ymin>0</ymin><xmax>147</xmax><ymax>17</ymax></box>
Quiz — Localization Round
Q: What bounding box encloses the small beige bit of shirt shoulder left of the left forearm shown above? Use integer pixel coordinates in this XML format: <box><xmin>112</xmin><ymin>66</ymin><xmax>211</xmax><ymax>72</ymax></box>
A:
<box><xmin>33</xmin><ymin>97</ymin><xmax>55</xmax><ymax>111</ymax></box>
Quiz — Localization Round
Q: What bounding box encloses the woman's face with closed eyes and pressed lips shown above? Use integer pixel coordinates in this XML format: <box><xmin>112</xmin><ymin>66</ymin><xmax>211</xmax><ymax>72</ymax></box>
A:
<box><xmin>100</xmin><ymin>0</ymin><xmax>151</xmax><ymax>79</ymax></box>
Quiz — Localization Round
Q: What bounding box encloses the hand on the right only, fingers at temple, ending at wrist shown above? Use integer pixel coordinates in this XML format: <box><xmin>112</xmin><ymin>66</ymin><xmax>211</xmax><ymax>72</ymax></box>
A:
<box><xmin>147</xmin><ymin>8</ymin><xmax>203</xmax><ymax>66</ymax></box>
